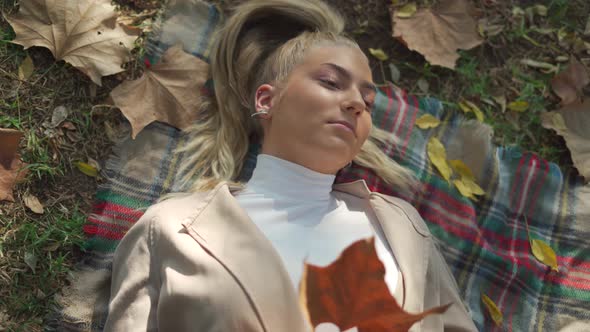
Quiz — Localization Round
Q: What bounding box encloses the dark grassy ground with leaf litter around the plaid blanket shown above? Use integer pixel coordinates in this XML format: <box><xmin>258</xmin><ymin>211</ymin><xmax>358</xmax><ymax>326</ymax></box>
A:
<box><xmin>0</xmin><ymin>0</ymin><xmax>590</xmax><ymax>331</ymax></box>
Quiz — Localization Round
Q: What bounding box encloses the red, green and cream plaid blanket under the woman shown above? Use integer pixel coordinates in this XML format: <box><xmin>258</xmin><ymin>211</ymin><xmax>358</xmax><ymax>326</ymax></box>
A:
<box><xmin>49</xmin><ymin>0</ymin><xmax>590</xmax><ymax>331</ymax></box>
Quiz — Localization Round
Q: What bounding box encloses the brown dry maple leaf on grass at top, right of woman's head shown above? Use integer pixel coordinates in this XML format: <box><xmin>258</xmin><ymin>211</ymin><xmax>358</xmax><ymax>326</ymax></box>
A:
<box><xmin>391</xmin><ymin>0</ymin><xmax>483</xmax><ymax>69</ymax></box>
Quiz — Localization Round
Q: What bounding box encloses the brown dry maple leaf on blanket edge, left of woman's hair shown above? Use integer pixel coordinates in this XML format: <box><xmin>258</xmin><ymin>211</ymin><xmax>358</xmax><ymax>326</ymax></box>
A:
<box><xmin>111</xmin><ymin>45</ymin><xmax>209</xmax><ymax>138</ymax></box>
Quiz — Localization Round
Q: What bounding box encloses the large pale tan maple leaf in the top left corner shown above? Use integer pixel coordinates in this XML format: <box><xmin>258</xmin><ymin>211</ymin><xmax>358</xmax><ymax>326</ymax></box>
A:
<box><xmin>7</xmin><ymin>0</ymin><xmax>139</xmax><ymax>85</ymax></box>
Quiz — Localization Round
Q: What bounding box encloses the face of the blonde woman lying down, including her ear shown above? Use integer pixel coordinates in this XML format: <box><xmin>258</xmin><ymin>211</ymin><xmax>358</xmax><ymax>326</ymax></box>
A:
<box><xmin>256</xmin><ymin>46</ymin><xmax>375</xmax><ymax>174</ymax></box>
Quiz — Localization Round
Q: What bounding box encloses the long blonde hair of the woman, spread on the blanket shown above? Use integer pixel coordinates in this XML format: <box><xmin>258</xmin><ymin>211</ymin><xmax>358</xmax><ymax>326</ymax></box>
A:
<box><xmin>178</xmin><ymin>0</ymin><xmax>414</xmax><ymax>191</ymax></box>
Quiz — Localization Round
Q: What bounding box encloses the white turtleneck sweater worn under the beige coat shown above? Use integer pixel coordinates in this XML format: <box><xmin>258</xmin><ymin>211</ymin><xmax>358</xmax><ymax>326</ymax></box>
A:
<box><xmin>236</xmin><ymin>154</ymin><xmax>398</xmax><ymax>294</ymax></box>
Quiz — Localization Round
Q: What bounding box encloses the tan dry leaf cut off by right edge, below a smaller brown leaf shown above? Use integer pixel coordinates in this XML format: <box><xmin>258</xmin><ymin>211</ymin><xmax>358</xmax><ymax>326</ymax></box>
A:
<box><xmin>541</xmin><ymin>99</ymin><xmax>590</xmax><ymax>182</ymax></box>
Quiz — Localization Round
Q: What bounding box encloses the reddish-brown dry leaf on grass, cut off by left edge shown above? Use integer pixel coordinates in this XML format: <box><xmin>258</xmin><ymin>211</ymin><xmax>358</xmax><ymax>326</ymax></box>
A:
<box><xmin>0</xmin><ymin>128</ymin><xmax>26</xmax><ymax>202</ymax></box>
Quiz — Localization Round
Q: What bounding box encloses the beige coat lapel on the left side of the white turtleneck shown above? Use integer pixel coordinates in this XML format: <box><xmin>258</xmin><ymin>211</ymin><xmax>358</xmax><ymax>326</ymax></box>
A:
<box><xmin>183</xmin><ymin>182</ymin><xmax>308</xmax><ymax>331</ymax></box>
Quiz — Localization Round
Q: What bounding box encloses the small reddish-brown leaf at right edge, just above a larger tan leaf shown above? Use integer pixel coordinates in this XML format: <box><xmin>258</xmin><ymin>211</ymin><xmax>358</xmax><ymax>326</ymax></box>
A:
<box><xmin>551</xmin><ymin>56</ymin><xmax>590</xmax><ymax>105</ymax></box>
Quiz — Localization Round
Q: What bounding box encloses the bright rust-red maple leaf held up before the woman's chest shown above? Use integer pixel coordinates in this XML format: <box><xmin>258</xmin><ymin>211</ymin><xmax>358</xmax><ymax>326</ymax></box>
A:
<box><xmin>299</xmin><ymin>238</ymin><xmax>451</xmax><ymax>332</ymax></box>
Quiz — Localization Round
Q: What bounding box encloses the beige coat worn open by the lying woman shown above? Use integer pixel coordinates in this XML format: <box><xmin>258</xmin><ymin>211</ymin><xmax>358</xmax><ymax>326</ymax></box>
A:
<box><xmin>105</xmin><ymin>180</ymin><xmax>476</xmax><ymax>332</ymax></box>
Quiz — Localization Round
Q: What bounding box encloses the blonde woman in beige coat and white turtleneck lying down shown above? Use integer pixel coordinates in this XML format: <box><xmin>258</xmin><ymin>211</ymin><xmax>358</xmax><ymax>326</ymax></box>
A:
<box><xmin>106</xmin><ymin>0</ymin><xmax>476</xmax><ymax>332</ymax></box>
